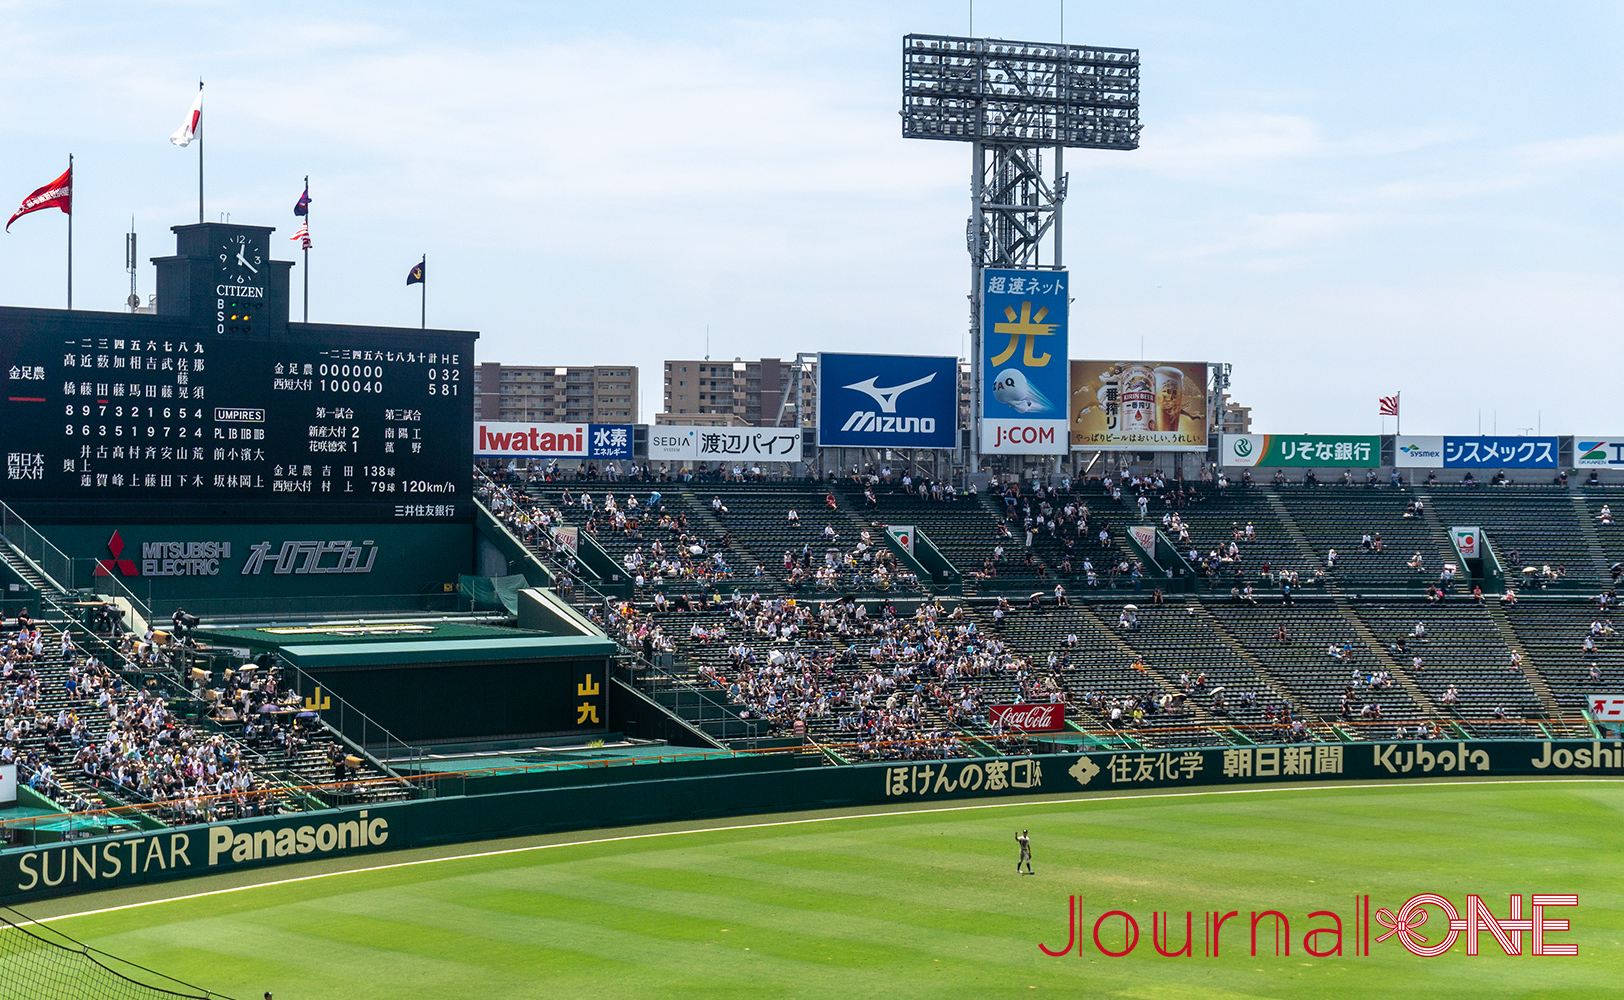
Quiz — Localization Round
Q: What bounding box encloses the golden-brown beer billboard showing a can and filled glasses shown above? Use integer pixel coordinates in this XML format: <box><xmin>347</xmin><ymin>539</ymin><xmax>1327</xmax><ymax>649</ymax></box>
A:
<box><xmin>1070</xmin><ymin>360</ymin><xmax>1207</xmax><ymax>451</ymax></box>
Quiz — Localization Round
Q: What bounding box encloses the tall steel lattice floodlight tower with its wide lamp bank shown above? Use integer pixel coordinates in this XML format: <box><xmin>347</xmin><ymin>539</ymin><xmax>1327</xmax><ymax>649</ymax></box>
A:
<box><xmin>901</xmin><ymin>34</ymin><xmax>1140</xmax><ymax>471</ymax></box>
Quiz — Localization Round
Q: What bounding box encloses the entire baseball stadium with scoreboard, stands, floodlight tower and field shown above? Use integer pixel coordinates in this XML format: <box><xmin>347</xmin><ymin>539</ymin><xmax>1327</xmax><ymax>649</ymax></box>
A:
<box><xmin>0</xmin><ymin>3</ymin><xmax>1624</xmax><ymax>1000</ymax></box>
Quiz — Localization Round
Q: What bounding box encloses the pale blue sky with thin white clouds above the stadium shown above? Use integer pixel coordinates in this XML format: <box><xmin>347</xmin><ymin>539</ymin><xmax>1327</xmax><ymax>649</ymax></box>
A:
<box><xmin>0</xmin><ymin>0</ymin><xmax>1624</xmax><ymax>437</ymax></box>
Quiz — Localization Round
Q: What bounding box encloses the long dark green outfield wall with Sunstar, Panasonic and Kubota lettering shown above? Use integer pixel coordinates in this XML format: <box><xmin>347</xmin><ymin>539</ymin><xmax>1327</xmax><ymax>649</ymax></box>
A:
<box><xmin>0</xmin><ymin>740</ymin><xmax>1624</xmax><ymax>903</ymax></box>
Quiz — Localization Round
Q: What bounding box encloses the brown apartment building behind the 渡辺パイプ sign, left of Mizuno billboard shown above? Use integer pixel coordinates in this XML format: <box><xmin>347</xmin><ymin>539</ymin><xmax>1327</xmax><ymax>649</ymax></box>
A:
<box><xmin>654</xmin><ymin>357</ymin><xmax>817</xmax><ymax>427</ymax></box>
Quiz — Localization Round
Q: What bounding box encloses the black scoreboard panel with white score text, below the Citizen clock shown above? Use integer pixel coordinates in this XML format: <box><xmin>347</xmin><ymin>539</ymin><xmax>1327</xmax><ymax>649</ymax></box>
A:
<box><xmin>0</xmin><ymin>308</ymin><xmax>474</xmax><ymax>523</ymax></box>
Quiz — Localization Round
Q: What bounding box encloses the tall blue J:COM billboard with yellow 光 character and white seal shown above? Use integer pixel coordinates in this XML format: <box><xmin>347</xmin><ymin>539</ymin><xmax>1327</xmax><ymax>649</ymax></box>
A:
<box><xmin>981</xmin><ymin>268</ymin><xmax>1070</xmax><ymax>455</ymax></box>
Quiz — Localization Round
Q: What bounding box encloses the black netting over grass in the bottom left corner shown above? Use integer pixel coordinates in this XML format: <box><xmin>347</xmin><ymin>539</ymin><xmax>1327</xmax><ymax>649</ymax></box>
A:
<box><xmin>0</xmin><ymin>907</ymin><xmax>243</xmax><ymax>1000</ymax></box>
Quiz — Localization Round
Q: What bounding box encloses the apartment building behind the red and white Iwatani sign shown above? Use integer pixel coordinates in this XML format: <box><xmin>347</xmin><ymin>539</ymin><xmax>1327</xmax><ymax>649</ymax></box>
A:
<box><xmin>474</xmin><ymin>362</ymin><xmax>637</xmax><ymax>424</ymax></box>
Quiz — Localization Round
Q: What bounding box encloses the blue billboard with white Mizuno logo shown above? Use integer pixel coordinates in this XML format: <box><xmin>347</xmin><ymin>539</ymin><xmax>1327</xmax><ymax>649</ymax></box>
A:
<box><xmin>817</xmin><ymin>354</ymin><xmax>958</xmax><ymax>448</ymax></box>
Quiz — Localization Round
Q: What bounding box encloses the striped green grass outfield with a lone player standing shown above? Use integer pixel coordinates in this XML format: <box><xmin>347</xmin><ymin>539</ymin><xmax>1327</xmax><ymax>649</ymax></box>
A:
<box><xmin>15</xmin><ymin>779</ymin><xmax>1624</xmax><ymax>1000</ymax></box>
